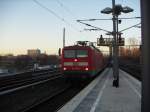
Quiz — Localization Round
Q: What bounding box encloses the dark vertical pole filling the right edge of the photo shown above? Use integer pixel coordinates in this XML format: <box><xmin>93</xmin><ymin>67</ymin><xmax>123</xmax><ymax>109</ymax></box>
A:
<box><xmin>141</xmin><ymin>0</ymin><xmax>150</xmax><ymax>112</ymax></box>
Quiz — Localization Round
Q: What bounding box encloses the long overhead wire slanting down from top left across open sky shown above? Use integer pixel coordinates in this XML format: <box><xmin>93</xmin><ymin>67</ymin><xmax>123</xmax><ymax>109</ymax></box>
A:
<box><xmin>33</xmin><ymin>0</ymin><xmax>81</xmax><ymax>32</ymax></box>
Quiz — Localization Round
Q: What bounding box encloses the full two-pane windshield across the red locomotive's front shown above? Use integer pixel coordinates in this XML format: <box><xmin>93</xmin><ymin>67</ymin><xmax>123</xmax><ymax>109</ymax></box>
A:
<box><xmin>64</xmin><ymin>50</ymin><xmax>88</xmax><ymax>58</ymax></box>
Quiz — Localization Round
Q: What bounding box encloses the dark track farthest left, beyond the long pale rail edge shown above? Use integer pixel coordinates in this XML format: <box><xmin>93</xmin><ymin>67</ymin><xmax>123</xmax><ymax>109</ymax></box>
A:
<box><xmin>0</xmin><ymin>69</ymin><xmax>61</xmax><ymax>91</ymax></box>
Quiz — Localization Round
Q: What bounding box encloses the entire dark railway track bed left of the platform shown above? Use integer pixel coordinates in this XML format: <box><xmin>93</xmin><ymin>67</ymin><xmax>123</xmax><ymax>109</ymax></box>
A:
<box><xmin>0</xmin><ymin>65</ymin><xmax>107</xmax><ymax>112</ymax></box>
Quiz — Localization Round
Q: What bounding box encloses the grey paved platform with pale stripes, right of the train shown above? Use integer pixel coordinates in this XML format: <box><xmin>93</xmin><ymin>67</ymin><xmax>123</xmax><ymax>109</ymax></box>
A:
<box><xmin>58</xmin><ymin>68</ymin><xmax>141</xmax><ymax>112</ymax></box>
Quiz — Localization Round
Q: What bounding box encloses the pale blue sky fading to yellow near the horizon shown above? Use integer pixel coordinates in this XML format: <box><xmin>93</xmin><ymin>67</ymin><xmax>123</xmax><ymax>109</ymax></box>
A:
<box><xmin>0</xmin><ymin>0</ymin><xmax>141</xmax><ymax>55</ymax></box>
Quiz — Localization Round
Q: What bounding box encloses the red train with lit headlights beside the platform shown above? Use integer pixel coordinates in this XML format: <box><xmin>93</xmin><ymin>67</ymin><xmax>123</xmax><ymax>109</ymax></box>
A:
<box><xmin>61</xmin><ymin>41</ymin><xmax>104</xmax><ymax>79</ymax></box>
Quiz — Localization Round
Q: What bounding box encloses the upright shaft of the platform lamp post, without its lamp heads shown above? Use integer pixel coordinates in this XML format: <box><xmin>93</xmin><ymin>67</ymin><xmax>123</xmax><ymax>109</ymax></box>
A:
<box><xmin>112</xmin><ymin>0</ymin><xmax>119</xmax><ymax>87</ymax></box>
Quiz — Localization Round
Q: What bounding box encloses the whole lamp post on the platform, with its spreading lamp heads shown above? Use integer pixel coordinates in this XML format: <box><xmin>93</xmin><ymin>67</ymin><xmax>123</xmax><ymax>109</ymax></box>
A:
<box><xmin>101</xmin><ymin>0</ymin><xmax>133</xmax><ymax>87</ymax></box>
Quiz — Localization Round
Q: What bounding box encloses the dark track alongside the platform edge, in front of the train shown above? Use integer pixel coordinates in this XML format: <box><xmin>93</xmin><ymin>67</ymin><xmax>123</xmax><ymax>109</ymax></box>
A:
<box><xmin>22</xmin><ymin>82</ymin><xmax>90</xmax><ymax>112</ymax></box>
